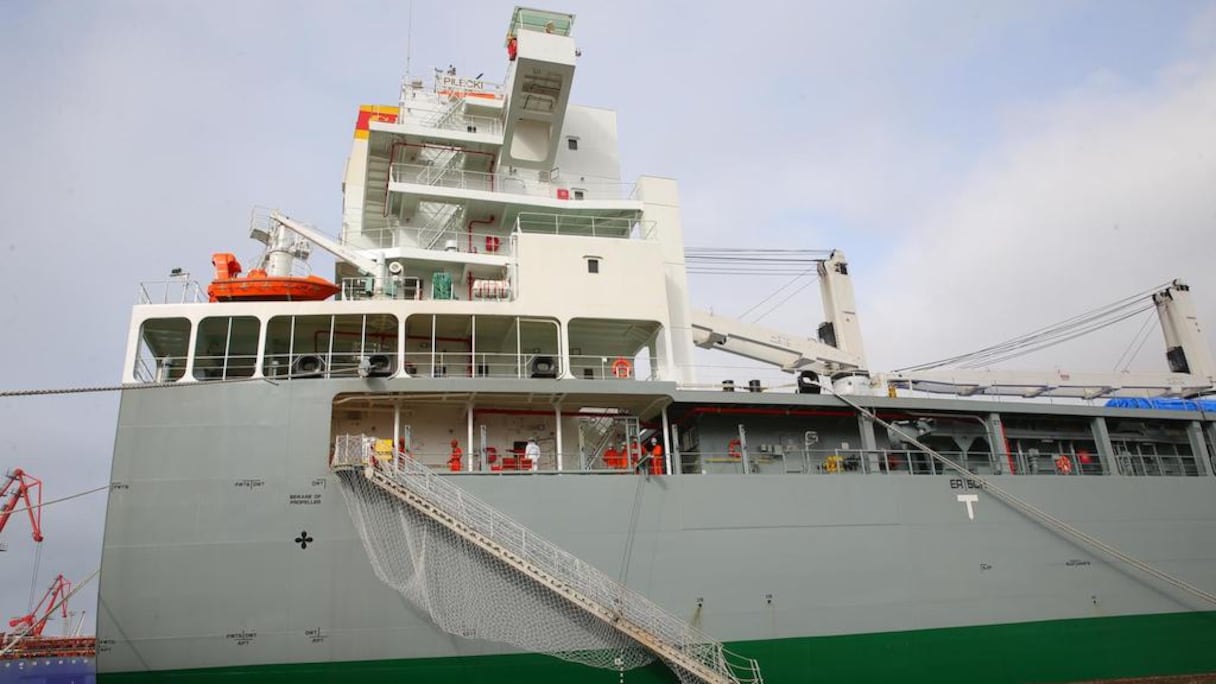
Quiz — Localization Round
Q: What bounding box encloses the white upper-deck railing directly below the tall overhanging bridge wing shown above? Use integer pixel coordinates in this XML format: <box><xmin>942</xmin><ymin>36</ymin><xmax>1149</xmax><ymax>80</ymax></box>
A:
<box><xmin>389</xmin><ymin>163</ymin><xmax>634</xmax><ymax>201</ymax></box>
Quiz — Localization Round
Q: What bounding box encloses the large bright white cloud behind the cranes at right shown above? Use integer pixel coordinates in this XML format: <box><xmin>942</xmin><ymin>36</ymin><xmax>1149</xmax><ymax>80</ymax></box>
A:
<box><xmin>862</xmin><ymin>53</ymin><xmax>1216</xmax><ymax>370</ymax></box>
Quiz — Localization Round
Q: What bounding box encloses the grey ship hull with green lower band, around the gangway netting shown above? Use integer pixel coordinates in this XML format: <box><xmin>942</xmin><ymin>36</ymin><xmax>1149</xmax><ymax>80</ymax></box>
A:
<box><xmin>97</xmin><ymin>381</ymin><xmax>1216</xmax><ymax>683</ymax></box>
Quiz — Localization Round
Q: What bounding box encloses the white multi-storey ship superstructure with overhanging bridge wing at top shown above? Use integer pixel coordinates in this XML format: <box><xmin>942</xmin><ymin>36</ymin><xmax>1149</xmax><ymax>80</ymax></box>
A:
<box><xmin>306</xmin><ymin>7</ymin><xmax>693</xmax><ymax>380</ymax></box>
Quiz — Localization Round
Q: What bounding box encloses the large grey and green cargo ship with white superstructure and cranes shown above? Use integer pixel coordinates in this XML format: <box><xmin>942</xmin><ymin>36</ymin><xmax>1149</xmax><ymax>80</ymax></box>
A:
<box><xmin>96</xmin><ymin>7</ymin><xmax>1216</xmax><ymax>684</ymax></box>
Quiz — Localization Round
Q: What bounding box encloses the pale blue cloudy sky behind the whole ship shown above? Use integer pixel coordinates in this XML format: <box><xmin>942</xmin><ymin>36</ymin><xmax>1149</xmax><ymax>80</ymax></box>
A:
<box><xmin>0</xmin><ymin>0</ymin><xmax>1216</xmax><ymax>632</ymax></box>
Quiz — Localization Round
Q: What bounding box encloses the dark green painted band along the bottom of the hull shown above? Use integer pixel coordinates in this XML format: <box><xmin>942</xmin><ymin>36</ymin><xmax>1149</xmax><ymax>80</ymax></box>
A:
<box><xmin>98</xmin><ymin>612</ymin><xmax>1216</xmax><ymax>684</ymax></box>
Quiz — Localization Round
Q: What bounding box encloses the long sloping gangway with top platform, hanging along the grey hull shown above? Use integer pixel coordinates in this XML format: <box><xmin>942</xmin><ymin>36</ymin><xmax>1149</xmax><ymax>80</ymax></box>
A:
<box><xmin>331</xmin><ymin>434</ymin><xmax>762</xmax><ymax>684</ymax></box>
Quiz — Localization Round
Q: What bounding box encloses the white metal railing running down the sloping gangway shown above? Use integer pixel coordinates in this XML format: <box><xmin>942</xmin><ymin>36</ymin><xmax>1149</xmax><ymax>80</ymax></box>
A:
<box><xmin>333</xmin><ymin>434</ymin><xmax>761</xmax><ymax>683</ymax></box>
